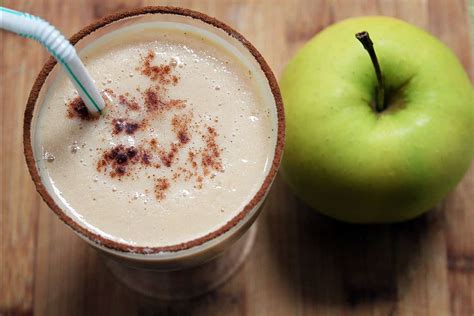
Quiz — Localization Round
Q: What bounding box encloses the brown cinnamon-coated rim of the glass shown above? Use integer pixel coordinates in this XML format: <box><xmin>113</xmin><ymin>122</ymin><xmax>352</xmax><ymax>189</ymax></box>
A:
<box><xmin>23</xmin><ymin>6</ymin><xmax>285</xmax><ymax>254</ymax></box>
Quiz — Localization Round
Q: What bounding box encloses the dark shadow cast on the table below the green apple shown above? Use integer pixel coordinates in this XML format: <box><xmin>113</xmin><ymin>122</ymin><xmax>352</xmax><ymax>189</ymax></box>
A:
<box><xmin>269</xmin><ymin>179</ymin><xmax>443</xmax><ymax>309</ymax></box>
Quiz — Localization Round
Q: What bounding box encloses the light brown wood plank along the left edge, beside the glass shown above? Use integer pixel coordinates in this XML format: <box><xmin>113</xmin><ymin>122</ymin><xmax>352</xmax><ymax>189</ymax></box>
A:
<box><xmin>0</xmin><ymin>0</ymin><xmax>46</xmax><ymax>315</ymax></box>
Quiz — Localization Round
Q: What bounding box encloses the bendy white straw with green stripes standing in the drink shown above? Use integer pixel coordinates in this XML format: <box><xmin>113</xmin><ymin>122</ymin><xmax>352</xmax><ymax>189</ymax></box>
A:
<box><xmin>0</xmin><ymin>7</ymin><xmax>105</xmax><ymax>113</ymax></box>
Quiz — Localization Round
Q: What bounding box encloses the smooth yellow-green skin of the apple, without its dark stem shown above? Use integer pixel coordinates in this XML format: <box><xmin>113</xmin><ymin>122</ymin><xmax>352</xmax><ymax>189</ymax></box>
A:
<box><xmin>280</xmin><ymin>17</ymin><xmax>474</xmax><ymax>223</ymax></box>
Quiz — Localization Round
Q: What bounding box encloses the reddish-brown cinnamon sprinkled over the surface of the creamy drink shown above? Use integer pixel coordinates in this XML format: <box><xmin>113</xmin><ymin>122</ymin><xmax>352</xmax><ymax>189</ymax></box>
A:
<box><xmin>93</xmin><ymin>51</ymin><xmax>223</xmax><ymax>201</ymax></box>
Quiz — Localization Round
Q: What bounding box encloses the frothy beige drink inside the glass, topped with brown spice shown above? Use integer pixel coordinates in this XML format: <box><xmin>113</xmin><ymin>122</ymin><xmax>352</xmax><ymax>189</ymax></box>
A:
<box><xmin>34</xmin><ymin>23</ymin><xmax>276</xmax><ymax>247</ymax></box>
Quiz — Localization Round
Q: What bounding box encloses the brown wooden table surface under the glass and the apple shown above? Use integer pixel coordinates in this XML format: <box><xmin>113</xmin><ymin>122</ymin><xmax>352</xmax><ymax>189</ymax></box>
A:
<box><xmin>0</xmin><ymin>0</ymin><xmax>474</xmax><ymax>316</ymax></box>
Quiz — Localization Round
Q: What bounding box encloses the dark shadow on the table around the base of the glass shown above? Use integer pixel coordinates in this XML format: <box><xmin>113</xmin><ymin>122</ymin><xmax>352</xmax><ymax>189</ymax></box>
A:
<box><xmin>78</xmin><ymin>249</ymin><xmax>245</xmax><ymax>316</ymax></box>
